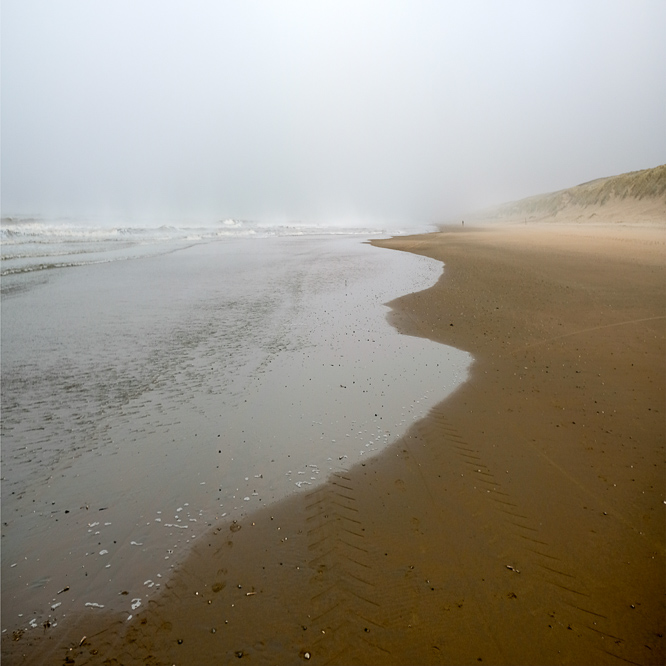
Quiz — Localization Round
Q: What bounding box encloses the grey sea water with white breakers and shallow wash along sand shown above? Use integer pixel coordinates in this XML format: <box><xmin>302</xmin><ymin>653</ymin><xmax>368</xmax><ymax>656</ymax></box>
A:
<box><xmin>2</xmin><ymin>221</ymin><xmax>471</xmax><ymax>631</ymax></box>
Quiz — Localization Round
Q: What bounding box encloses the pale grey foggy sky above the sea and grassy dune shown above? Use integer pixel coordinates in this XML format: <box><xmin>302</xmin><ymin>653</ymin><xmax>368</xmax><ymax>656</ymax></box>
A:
<box><xmin>2</xmin><ymin>0</ymin><xmax>666</xmax><ymax>222</ymax></box>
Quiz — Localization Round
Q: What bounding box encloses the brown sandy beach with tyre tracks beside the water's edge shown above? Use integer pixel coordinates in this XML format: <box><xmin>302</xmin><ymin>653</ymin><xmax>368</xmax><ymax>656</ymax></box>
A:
<box><xmin>3</xmin><ymin>220</ymin><xmax>666</xmax><ymax>664</ymax></box>
